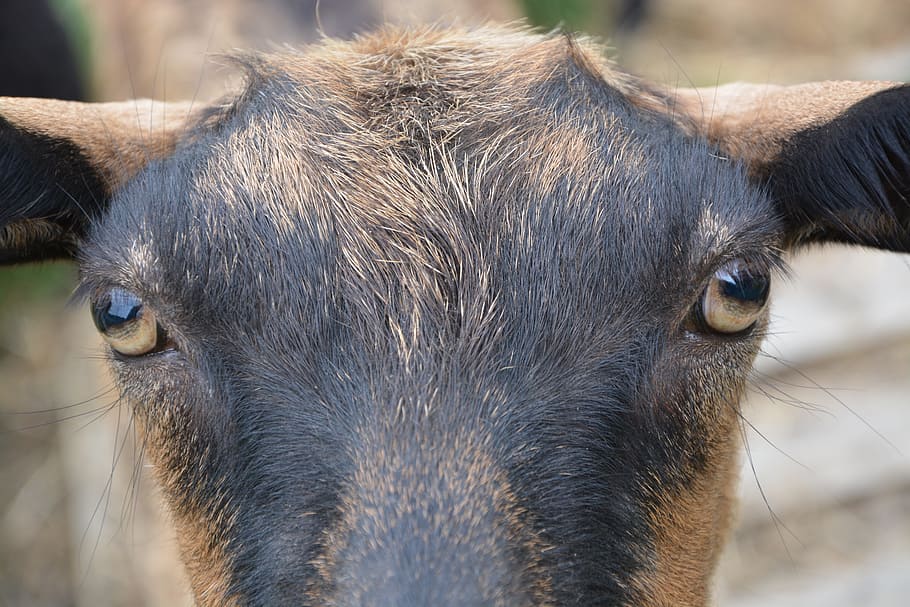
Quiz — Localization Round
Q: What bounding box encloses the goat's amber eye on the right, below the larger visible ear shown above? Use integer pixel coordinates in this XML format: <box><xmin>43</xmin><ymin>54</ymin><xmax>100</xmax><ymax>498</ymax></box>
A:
<box><xmin>701</xmin><ymin>259</ymin><xmax>771</xmax><ymax>335</ymax></box>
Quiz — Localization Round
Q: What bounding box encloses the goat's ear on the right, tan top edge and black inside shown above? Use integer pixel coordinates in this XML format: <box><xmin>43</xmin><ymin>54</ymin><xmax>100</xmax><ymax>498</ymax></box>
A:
<box><xmin>677</xmin><ymin>82</ymin><xmax>910</xmax><ymax>252</ymax></box>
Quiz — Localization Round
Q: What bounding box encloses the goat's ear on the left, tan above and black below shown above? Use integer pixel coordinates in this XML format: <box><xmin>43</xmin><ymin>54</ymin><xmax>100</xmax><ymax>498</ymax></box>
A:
<box><xmin>0</xmin><ymin>97</ymin><xmax>189</xmax><ymax>264</ymax></box>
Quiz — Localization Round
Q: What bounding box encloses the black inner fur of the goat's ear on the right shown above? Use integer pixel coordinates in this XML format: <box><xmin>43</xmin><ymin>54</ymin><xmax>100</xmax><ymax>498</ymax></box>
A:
<box><xmin>765</xmin><ymin>86</ymin><xmax>910</xmax><ymax>252</ymax></box>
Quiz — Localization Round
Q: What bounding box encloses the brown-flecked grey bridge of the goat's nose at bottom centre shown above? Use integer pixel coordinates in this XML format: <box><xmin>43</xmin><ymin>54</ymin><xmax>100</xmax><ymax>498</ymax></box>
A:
<box><xmin>320</xmin><ymin>420</ymin><xmax>549</xmax><ymax>607</ymax></box>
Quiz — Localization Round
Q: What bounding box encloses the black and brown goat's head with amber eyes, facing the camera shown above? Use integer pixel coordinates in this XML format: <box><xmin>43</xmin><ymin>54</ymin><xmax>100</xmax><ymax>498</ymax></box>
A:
<box><xmin>0</xmin><ymin>26</ymin><xmax>910</xmax><ymax>607</ymax></box>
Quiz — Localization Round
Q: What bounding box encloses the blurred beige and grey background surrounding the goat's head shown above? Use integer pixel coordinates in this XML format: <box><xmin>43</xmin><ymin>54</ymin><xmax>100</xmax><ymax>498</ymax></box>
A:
<box><xmin>0</xmin><ymin>0</ymin><xmax>910</xmax><ymax>607</ymax></box>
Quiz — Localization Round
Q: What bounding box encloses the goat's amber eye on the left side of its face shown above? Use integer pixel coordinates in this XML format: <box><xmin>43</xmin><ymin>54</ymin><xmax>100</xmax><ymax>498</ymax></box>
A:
<box><xmin>92</xmin><ymin>289</ymin><xmax>169</xmax><ymax>356</ymax></box>
